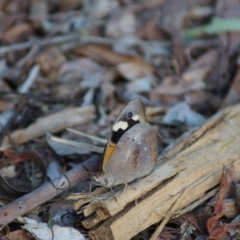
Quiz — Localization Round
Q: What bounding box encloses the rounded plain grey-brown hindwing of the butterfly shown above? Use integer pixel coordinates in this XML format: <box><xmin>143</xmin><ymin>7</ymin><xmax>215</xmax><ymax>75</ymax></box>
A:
<box><xmin>105</xmin><ymin>123</ymin><xmax>158</xmax><ymax>185</ymax></box>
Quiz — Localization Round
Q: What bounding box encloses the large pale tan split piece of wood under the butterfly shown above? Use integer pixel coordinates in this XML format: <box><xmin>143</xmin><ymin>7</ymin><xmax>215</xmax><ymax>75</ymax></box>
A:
<box><xmin>82</xmin><ymin>105</ymin><xmax>240</xmax><ymax>240</ymax></box>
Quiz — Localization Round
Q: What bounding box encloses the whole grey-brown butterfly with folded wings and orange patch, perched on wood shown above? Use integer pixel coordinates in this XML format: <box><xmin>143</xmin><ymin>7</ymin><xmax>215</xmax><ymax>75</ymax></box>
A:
<box><xmin>95</xmin><ymin>99</ymin><xmax>158</xmax><ymax>187</ymax></box>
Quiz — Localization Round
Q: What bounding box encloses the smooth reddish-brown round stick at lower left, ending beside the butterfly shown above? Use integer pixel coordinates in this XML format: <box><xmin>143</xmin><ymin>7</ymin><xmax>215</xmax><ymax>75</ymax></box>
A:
<box><xmin>0</xmin><ymin>156</ymin><xmax>99</xmax><ymax>230</ymax></box>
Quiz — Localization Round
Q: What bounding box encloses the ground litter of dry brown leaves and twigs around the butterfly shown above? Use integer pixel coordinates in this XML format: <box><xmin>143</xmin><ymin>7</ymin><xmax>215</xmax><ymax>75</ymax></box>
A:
<box><xmin>0</xmin><ymin>0</ymin><xmax>240</xmax><ymax>240</ymax></box>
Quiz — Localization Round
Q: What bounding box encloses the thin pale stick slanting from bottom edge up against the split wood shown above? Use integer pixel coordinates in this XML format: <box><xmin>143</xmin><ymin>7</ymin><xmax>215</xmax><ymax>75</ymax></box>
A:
<box><xmin>150</xmin><ymin>190</ymin><xmax>187</xmax><ymax>240</ymax></box>
